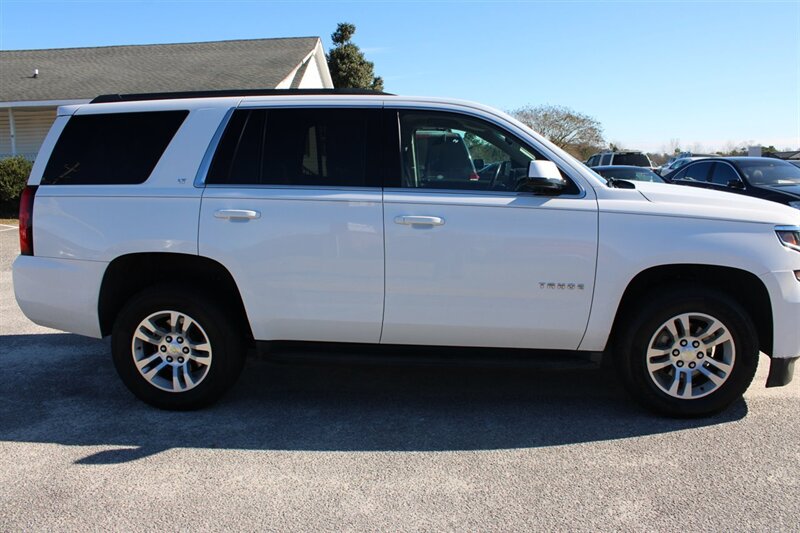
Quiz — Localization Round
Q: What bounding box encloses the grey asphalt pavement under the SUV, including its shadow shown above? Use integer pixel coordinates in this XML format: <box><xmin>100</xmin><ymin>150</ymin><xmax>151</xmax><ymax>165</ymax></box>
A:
<box><xmin>0</xmin><ymin>226</ymin><xmax>800</xmax><ymax>531</ymax></box>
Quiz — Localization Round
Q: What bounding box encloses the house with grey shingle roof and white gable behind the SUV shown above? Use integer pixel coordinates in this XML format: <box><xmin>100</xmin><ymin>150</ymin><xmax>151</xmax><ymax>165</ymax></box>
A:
<box><xmin>0</xmin><ymin>37</ymin><xmax>333</xmax><ymax>159</ymax></box>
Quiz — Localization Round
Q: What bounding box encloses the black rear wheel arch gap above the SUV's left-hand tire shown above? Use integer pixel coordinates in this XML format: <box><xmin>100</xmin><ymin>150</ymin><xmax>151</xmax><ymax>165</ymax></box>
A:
<box><xmin>97</xmin><ymin>252</ymin><xmax>253</xmax><ymax>340</ymax></box>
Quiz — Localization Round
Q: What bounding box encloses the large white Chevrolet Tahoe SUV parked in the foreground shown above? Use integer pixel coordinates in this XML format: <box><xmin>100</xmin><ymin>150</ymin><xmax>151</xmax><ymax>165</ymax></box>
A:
<box><xmin>14</xmin><ymin>91</ymin><xmax>800</xmax><ymax>416</ymax></box>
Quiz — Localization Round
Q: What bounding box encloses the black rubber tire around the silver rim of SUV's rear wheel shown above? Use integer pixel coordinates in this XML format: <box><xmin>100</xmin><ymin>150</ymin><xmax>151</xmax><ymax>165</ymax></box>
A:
<box><xmin>111</xmin><ymin>286</ymin><xmax>245</xmax><ymax>410</ymax></box>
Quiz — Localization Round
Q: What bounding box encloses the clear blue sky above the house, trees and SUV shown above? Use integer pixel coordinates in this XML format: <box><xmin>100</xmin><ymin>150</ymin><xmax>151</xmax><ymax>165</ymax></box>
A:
<box><xmin>0</xmin><ymin>0</ymin><xmax>800</xmax><ymax>150</ymax></box>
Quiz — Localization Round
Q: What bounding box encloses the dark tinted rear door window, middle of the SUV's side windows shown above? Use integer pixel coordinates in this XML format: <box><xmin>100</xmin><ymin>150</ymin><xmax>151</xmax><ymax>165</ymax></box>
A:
<box><xmin>206</xmin><ymin>109</ymin><xmax>381</xmax><ymax>187</ymax></box>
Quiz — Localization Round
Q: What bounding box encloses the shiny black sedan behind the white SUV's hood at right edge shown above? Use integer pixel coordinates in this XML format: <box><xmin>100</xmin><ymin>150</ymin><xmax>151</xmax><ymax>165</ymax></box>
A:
<box><xmin>669</xmin><ymin>157</ymin><xmax>800</xmax><ymax>209</ymax></box>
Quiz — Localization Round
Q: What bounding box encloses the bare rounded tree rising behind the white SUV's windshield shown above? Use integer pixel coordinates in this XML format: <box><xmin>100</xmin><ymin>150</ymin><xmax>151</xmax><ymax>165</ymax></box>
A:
<box><xmin>511</xmin><ymin>105</ymin><xmax>605</xmax><ymax>159</ymax></box>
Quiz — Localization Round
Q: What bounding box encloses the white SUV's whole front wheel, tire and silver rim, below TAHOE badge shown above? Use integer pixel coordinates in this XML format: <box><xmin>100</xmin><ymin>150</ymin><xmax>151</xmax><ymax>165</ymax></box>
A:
<box><xmin>615</xmin><ymin>287</ymin><xmax>758</xmax><ymax>416</ymax></box>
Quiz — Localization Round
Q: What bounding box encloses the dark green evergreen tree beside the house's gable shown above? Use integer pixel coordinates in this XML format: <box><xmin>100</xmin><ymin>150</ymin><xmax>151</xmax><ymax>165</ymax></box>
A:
<box><xmin>326</xmin><ymin>22</ymin><xmax>383</xmax><ymax>91</ymax></box>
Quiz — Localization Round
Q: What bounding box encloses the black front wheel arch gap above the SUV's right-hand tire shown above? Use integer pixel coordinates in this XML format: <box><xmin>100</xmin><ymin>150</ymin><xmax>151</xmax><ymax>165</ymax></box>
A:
<box><xmin>606</xmin><ymin>264</ymin><xmax>773</xmax><ymax>355</ymax></box>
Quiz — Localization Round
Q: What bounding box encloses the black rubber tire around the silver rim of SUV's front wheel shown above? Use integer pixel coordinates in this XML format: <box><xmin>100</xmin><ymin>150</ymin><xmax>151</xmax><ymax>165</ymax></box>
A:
<box><xmin>614</xmin><ymin>285</ymin><xmax>759</xmax><ymax>417</ymax></box>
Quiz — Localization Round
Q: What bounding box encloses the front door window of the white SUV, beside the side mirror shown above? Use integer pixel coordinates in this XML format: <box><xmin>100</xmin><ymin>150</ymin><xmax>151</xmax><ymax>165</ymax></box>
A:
<box><xmin>400</xmin><ymin>111</ymin><xmax>577</xmax><ymax>192</ymax></box>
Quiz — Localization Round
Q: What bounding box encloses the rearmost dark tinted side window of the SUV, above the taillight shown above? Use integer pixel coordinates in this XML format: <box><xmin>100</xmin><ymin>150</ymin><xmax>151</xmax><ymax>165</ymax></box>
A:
<box><xmin>42</xmin><ymin>111</ymin><xmax>189</xmax><ymax>185</ymax></box>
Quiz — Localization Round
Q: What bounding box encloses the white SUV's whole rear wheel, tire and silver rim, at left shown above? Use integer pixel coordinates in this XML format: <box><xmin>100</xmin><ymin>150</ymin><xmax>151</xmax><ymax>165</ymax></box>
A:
<box><xmin>111</xmin><ymin>286</ymin><xmax>244</xmax><ymax>410</ymax></box>
